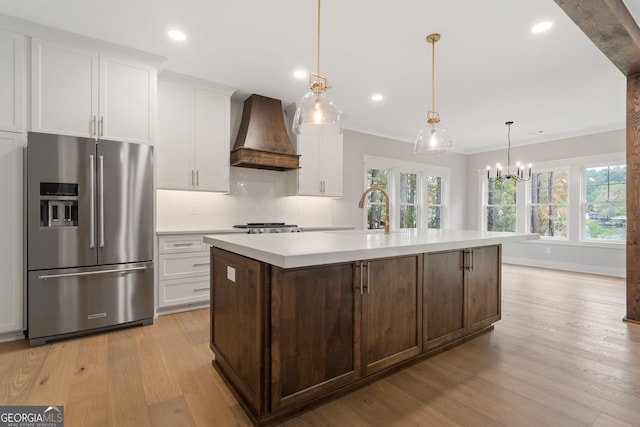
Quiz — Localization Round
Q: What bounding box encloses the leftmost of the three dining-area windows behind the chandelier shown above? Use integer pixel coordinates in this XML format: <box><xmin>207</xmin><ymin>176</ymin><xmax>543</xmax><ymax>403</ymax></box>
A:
<box><xmin>486</xmin><ymin>179</ymin><xmax>516</xmax><ymax>231</ymax></box>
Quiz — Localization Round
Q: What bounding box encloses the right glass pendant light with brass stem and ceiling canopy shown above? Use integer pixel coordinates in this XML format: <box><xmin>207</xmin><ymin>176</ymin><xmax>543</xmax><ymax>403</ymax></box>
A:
<box><xmin>413</xmin><ymin>33</ymin><xmax>453</xmax><ymax>154</ymax></box>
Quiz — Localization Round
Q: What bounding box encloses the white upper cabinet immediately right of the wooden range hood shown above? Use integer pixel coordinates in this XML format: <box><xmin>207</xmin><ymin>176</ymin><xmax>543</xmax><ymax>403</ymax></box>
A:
<box><xmin>298</xmin><ymin>135</ymin><xmax>343</xmax><ymax>197</ymax></box>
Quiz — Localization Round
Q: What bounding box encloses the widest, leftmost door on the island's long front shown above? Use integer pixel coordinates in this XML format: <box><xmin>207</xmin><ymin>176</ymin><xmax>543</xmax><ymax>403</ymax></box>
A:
<box><xmin>271</xmin><ymin>263</ymin><xmax>356</xmax><ymax>411</ymax></box>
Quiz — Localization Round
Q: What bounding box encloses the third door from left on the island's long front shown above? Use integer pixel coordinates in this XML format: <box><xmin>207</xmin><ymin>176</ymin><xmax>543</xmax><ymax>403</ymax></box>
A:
<box><xmin>423</xmin><ymin>250</ymin><xmax>467</xmax><ymax>350</ymax></box>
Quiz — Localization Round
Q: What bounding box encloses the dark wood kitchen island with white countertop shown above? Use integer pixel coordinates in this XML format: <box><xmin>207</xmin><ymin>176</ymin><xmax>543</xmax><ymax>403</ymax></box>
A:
<box><xmin>204</xmin><ymin>229</ymin><xmax>538</xmax><ymax>425</ymax></box>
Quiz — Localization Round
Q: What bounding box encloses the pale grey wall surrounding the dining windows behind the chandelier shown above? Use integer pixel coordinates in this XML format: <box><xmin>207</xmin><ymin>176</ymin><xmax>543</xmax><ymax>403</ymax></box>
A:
<box><xmin>466</xmin><ymin>130</ymin><xmax>626</xmax><ymax>277</ymax></box>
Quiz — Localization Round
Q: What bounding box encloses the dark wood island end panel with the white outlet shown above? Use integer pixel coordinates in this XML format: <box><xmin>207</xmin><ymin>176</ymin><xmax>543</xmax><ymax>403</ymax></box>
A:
<box><xmin>211</xmin><ymin>248</ymin><xmax>267</xmax><ymax>415</ymax></box>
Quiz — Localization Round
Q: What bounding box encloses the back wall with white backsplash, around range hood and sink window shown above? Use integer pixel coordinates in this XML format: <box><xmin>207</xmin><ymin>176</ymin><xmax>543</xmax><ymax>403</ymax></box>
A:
<box><xmin>156</xmin><ymin>101</ymin><xmax>466</xmax><ymax>231</ymax></box>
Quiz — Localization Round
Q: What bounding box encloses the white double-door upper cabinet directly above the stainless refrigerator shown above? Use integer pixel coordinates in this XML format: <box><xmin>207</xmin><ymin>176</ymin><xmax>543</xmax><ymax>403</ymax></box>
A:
<box><xmin>31</xmin><ymin>38</ymin><xmax>156</xmax><ymax>144</ymax></box>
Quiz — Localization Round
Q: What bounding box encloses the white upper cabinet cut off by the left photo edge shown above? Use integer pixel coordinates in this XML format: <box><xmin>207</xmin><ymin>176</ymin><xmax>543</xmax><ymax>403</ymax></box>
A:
<box><xmin>0</xmin><ymin>30</ymin><xmax>24</xmax><ymax>132</ymax></box>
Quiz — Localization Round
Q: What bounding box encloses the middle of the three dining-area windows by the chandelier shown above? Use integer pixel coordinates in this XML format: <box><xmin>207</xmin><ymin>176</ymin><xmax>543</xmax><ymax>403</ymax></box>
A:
<box><xmin>529</xmin><ymin>169</ymin><xmax>569</xmax><ymax>239</ymax></box>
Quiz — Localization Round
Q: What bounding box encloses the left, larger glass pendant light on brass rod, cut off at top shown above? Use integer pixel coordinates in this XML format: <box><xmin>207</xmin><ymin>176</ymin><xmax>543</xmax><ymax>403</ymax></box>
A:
<box><xmin>292</xmin><ymin>0</ymin><xmax>343</xmax><ymax>136</ymax></box>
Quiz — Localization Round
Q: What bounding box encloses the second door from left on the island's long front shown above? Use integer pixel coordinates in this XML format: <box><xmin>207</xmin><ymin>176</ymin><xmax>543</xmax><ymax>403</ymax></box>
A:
<box><xmin>356</xmin><ymin>254</ymin><xmax>422</xmax><ymax>375</ymax></box>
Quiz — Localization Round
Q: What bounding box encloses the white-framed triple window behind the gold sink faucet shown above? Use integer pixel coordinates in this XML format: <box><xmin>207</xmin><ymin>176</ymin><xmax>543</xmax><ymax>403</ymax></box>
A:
<box><xmin>363</xmin><ymin>156</ymin><xmax>449</xmax><ymax>230</ymax></box>
